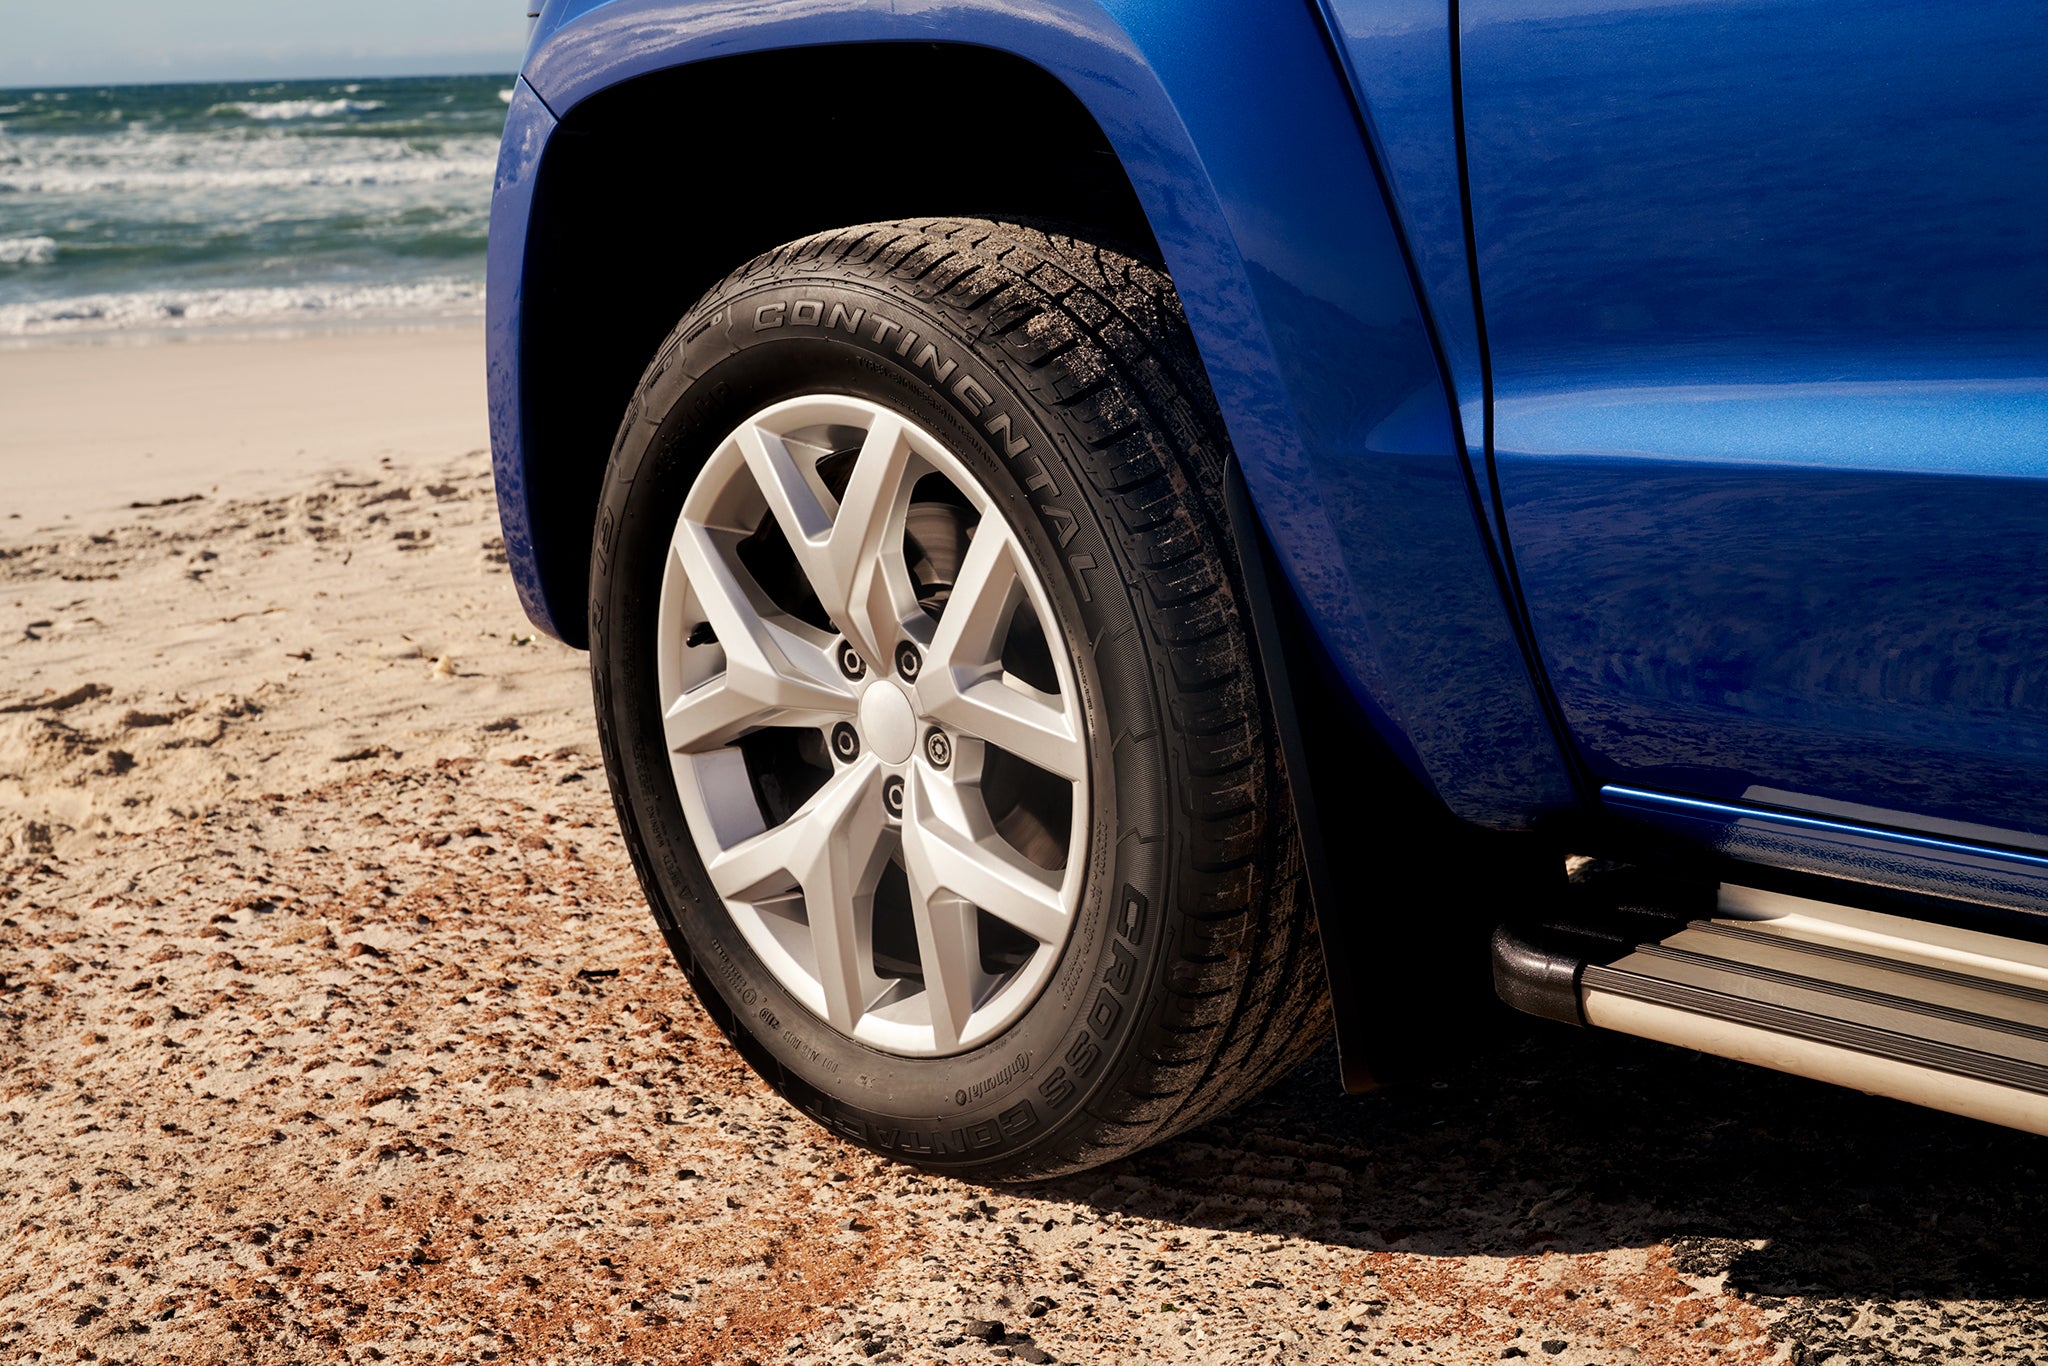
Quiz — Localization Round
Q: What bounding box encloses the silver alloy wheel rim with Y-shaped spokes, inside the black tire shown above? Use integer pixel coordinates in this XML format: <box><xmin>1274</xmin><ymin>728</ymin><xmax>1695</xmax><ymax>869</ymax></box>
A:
<box><xmin>655</xmin><ymin>395</ymin><xmax>1090</xmax><ymax>1057</ymax></box>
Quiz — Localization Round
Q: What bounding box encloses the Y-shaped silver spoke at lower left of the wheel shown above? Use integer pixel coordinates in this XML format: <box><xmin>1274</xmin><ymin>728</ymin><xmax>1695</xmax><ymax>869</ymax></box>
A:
<box><xmin>707</xmin><ymin>762</ymin><xmax>889</xmax><ymax>1032</ymax></box>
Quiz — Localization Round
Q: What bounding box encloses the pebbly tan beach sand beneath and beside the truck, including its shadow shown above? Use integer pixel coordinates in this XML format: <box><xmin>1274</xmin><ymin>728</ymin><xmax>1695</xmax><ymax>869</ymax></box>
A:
<box><xmin>0</xmin><ymin>334</ymin><xmax>2048</xmax><ymax>1366</ymax></box>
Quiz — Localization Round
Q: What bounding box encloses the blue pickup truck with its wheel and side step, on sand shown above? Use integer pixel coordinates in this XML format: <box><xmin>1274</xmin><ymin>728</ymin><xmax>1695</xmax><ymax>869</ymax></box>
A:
<box><xmin>489</xmin><ymin>0</ymin><xmax>2048</xmax><ymax>1180</ymax></box>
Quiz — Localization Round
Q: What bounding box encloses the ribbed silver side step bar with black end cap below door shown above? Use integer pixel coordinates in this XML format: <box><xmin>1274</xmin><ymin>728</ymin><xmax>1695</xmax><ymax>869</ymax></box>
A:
<box><xmin>1493</xmin><ymin>887</ymin><xmax>2048</xmax><ymax>1135</ymax></box>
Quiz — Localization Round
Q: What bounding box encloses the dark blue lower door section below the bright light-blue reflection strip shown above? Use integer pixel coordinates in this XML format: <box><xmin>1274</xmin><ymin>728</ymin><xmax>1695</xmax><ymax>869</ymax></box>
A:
<box><xmin>1503</xmin><ymin>457</ymin><xmax>2048</xmax><ymax>829</ymax></box>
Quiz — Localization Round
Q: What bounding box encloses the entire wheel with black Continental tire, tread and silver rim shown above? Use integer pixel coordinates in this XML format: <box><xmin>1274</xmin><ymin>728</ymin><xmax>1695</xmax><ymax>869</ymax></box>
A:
<box><xmin>590</xmin><ymin>219</ymin><xmax>1329</xmax><ymax>1182</ymax></box>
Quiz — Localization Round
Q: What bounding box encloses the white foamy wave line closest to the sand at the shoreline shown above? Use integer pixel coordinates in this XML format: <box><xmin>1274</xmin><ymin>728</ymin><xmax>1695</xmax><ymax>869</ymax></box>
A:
<box><xmin>0</xmin><ymin>276</ymin><xmax>483</xmax><ymax>338</ymax></box>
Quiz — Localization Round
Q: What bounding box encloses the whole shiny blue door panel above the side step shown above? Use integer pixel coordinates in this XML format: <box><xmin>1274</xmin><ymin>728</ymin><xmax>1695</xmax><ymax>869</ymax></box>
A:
<box><xmin>1462</xmin><ymin>0</ymin><xmax>2048</xmax><ymax>844</ymax></box>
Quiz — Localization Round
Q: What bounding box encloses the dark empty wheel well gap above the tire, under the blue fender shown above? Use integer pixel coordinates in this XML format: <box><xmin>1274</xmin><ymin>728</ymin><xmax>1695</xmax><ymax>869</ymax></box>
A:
<box><xmin>520</xmin><ymin>43</ymin><xmax>1159</xmax><ymax>645</ymax></box>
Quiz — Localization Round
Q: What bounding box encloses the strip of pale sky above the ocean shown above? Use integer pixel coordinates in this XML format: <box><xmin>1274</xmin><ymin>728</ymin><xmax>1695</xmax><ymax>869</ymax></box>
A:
<box><xmin>0</xmin><ymin>0</ymin><xmax>539</xmax><ymax>88</ymax></box>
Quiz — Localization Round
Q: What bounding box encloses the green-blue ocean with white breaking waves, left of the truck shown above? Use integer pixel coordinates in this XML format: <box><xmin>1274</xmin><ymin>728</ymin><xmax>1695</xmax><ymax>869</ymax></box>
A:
<box><xmin>0</xmin><ymin>76</ymin><xmax>512</xmax><ymax>344</ymax></box>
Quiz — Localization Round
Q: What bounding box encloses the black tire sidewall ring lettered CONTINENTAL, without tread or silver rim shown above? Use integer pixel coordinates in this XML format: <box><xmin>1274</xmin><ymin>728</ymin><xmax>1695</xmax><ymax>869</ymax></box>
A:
<box><xmin>590</xmin><ymin>266</ymin><xmax>1174</xmax><ymax>1173</ymax></box>
